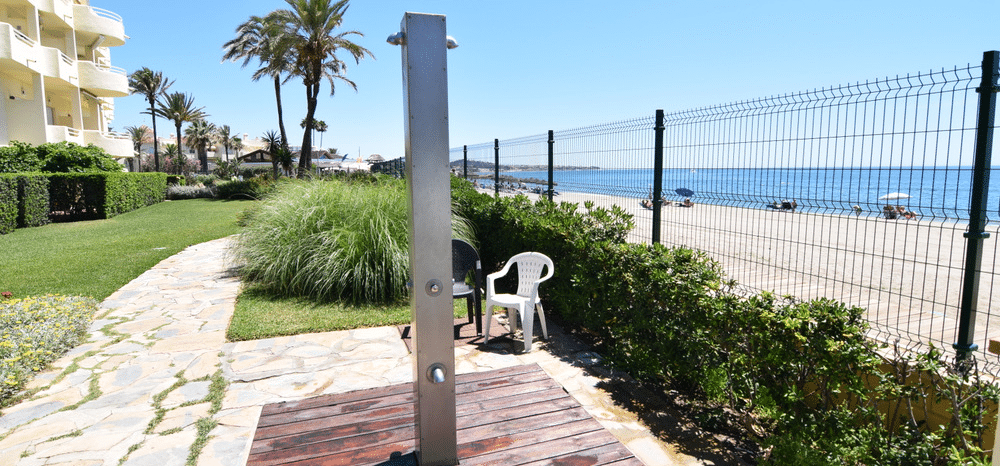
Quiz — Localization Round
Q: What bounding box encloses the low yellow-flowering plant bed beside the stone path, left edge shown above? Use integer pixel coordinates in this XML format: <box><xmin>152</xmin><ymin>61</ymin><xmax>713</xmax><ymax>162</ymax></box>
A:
<box><xmin>0</xmin><ymin>295</ymin><xmax>97</xmax><ymax>406</ymax></box>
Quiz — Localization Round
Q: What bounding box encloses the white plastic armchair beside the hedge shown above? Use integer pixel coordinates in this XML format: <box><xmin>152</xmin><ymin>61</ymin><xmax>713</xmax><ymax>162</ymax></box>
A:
<box><xmin>483</xmin><ymin>252</ymin><xmax>555</xmax><ymax>353</ymax></box>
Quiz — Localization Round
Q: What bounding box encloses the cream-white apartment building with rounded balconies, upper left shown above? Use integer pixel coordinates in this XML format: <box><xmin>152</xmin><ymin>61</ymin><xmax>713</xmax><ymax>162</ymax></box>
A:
<box><xmin>0</xmin><ymin>0</ymin><xmax>132</xmax><ymax>159</ymax></box>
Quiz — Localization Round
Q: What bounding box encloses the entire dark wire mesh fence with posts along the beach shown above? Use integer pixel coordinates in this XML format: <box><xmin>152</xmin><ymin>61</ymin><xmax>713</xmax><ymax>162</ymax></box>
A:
<box><xmin>451</xmin><ymin>52</ymin><xmax>1000</xmax><ymax>374</ymax></box>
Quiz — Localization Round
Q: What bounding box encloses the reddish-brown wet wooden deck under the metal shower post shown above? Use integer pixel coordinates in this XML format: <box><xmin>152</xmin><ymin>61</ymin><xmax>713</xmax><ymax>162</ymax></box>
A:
<box><xmin>247</xmin><ymin>364</ymin><xmax>642</xmax><ymax>466</ymax></box>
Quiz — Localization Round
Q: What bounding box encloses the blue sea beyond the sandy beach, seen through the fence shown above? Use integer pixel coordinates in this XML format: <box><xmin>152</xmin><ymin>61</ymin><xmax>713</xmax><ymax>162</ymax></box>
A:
<box><xmin>490</xmin><ymin>166</ymin><xmax>1000</xmax><ymax>224</ymax></box>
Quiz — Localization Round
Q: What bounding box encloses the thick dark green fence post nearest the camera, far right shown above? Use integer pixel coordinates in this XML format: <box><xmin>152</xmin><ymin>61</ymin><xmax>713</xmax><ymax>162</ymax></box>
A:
<box><xmin>952</xmin><ymin>50</ymin><xmax>1000</xmax><ymax>362</ymax></box>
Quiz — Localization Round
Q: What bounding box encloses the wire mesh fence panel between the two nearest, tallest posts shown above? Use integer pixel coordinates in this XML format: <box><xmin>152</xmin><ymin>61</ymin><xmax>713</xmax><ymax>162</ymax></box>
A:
<box><xmin>648</xmin><ymin>67</ymin><xmax>996</xmax><ymax>374</ymax></box>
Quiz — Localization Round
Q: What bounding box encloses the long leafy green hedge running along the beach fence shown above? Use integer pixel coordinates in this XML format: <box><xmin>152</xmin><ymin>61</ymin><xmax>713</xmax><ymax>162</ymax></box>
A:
<box><xmin>452</xmin><ymin>179</ymin><xmax>998</xmax><ymax>466</ymax></box>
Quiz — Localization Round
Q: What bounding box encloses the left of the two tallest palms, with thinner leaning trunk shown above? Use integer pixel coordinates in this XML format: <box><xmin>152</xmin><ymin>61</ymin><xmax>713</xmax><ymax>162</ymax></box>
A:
<box><xmin>222</xmin><ymin>13</ymin><xmax>293</xmax><ymax>147</ymax></box>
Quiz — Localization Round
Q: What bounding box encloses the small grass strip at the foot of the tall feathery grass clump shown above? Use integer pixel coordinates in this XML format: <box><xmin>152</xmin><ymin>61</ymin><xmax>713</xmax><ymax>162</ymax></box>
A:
<box><xmin>226</xmin><ymin>288</ymin><xmax>468</xmax><ymax>341</ymax></box>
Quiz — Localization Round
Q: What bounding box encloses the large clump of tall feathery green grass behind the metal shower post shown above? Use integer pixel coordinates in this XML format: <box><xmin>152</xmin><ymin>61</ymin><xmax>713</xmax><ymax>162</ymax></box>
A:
<box><xmin>232</xmin><ymin>177</ymin><xmax>470</xmax><ymax>303</ymax></box>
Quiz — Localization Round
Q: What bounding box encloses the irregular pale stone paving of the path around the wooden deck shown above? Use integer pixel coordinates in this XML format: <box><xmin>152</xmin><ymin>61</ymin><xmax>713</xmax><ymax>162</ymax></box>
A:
<box><xmin>0</xmin><ymin>238</ymin><xmax>715</xmax><ymax>466</ymax></box>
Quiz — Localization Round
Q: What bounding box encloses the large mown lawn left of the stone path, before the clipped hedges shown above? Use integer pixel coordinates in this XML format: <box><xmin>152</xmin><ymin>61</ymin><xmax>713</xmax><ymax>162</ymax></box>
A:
<box><xmin>0</xmin><ymin>199</ymin><xmax>253</xmax><ymax>301</ymax></box>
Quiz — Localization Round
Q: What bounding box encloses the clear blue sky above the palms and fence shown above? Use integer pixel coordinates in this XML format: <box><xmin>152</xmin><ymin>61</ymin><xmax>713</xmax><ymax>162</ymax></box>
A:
<box><xmin>101</xmin><ymin>0</ymin><xmax>1000</xmax><ymax>158</ymax></box>
